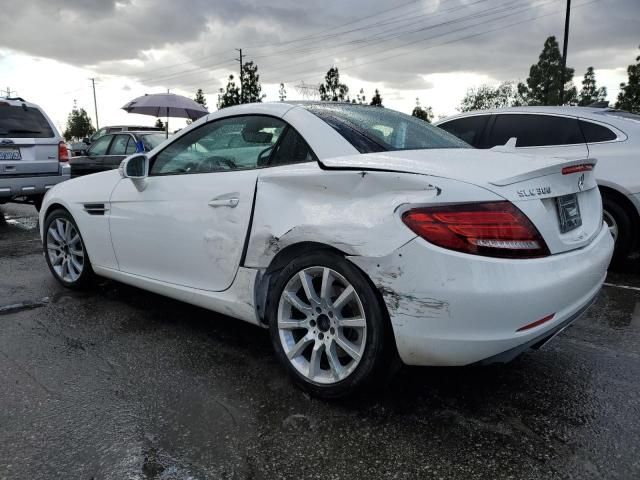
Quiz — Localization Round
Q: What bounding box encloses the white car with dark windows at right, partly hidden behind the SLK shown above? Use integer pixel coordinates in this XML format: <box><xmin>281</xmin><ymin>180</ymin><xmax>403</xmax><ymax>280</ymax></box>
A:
<box><xmin>436</xmin><ymin>107</ymin><xmax>640</xmax><ymax>260</ymax></box>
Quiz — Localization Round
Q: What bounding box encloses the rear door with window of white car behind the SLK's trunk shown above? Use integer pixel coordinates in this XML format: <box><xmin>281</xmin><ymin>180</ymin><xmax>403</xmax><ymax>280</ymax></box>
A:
<box><xmin>487</xmin><ymin>113</ymin><xmax>589</xmax><ymax>159</ymax></box>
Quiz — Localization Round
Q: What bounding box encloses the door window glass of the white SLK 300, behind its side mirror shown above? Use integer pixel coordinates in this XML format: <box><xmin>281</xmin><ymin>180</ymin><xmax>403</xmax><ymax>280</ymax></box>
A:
<box><xmin>150</xmin><ymin>115</ymin><xmax>286</xmax><ymax>176</ymax></box>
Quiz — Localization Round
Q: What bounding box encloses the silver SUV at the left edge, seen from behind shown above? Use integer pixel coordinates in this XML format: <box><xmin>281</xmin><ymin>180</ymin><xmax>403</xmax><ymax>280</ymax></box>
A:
<box><xmin>0</xmin><ymin>98</ymin><xmax>71</xmax><ymax>209</ymax></box>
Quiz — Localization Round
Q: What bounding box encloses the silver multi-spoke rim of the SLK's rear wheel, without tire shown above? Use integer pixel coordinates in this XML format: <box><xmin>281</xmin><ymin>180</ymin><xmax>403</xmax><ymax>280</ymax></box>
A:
<box><xmin>278</xmin><ymin>266</ymin><xmax>367</xmax><ymax>384</ymax></box>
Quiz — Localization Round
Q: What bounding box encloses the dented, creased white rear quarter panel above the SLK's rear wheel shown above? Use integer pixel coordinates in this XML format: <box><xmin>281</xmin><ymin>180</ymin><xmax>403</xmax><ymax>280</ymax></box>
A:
<box><xmin>245</xmin><ymin>163</ymin><xmax>439</xmax><ymax>268</ymax></box>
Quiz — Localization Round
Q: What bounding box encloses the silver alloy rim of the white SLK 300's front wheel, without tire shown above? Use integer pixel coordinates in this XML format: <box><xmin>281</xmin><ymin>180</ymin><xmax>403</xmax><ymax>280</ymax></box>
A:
<box><xmin>46</xmin><ymin>218</ymin><xmax>84</xmax><ymax>283</ymax></box>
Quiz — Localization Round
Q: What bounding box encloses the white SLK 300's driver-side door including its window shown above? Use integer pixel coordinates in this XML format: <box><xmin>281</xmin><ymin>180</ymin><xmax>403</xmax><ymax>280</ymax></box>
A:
<box><xmin>110</xmin><ymin>115</ymin><xmax>285</xmax><ymax>291</ymax></box>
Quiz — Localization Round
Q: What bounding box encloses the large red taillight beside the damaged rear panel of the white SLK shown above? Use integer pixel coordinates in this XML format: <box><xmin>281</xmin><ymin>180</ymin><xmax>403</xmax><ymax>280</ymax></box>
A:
<box><xmin>402</xmin><ymin>202</ymin><xmax>549</xmax><ymax>258</ymax></box>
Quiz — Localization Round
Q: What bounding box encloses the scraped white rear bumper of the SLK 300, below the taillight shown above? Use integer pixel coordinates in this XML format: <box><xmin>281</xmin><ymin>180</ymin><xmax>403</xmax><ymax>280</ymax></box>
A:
<box><xmin>350</xmin><ymin>223</ymin><xmax>613</xmax><ymax>365</ymax></box>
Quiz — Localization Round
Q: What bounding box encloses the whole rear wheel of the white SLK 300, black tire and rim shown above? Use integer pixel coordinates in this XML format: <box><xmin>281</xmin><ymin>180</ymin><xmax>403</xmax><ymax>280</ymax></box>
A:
<box><xmin>267</xmin><ymin>251</ymin><xmax>397</xmax><ymax>398</ymax></box>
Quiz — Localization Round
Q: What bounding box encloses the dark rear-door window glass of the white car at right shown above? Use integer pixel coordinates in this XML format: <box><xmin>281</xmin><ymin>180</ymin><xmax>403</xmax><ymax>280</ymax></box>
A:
<box><xmin>488</xmin><ymin>114</ymin><xmax>584</xmax><ymax>147</ymax></box>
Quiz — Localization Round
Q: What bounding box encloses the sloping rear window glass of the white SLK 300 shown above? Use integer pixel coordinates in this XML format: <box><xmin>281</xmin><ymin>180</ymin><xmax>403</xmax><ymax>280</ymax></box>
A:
<box><xmin>304</xmin><ymin>104</ymin><xmax>471</xmax><ymax>153</ymax></box>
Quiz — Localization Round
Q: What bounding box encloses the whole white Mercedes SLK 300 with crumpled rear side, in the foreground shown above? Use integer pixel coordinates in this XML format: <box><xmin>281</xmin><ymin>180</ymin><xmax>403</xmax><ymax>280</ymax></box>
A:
<box><xmin>40</xmin><ymin>102</ymin><xmax>613</xmax><ymax>397</ymax></box>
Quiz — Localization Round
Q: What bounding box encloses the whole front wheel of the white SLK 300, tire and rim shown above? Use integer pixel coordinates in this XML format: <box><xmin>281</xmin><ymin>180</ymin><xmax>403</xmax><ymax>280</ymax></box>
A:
<box><xmin>43</xmin><ymin>209</ymin><xmax>94</xmax><ymax>289</ymax></box>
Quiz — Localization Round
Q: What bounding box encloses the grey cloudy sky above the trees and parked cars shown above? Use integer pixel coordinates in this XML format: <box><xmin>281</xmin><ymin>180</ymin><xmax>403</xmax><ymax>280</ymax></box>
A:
<box><xmin>0</xmin><ymin>0</ymin><xmax>640</xmax><ymax>129</ymax></box>
